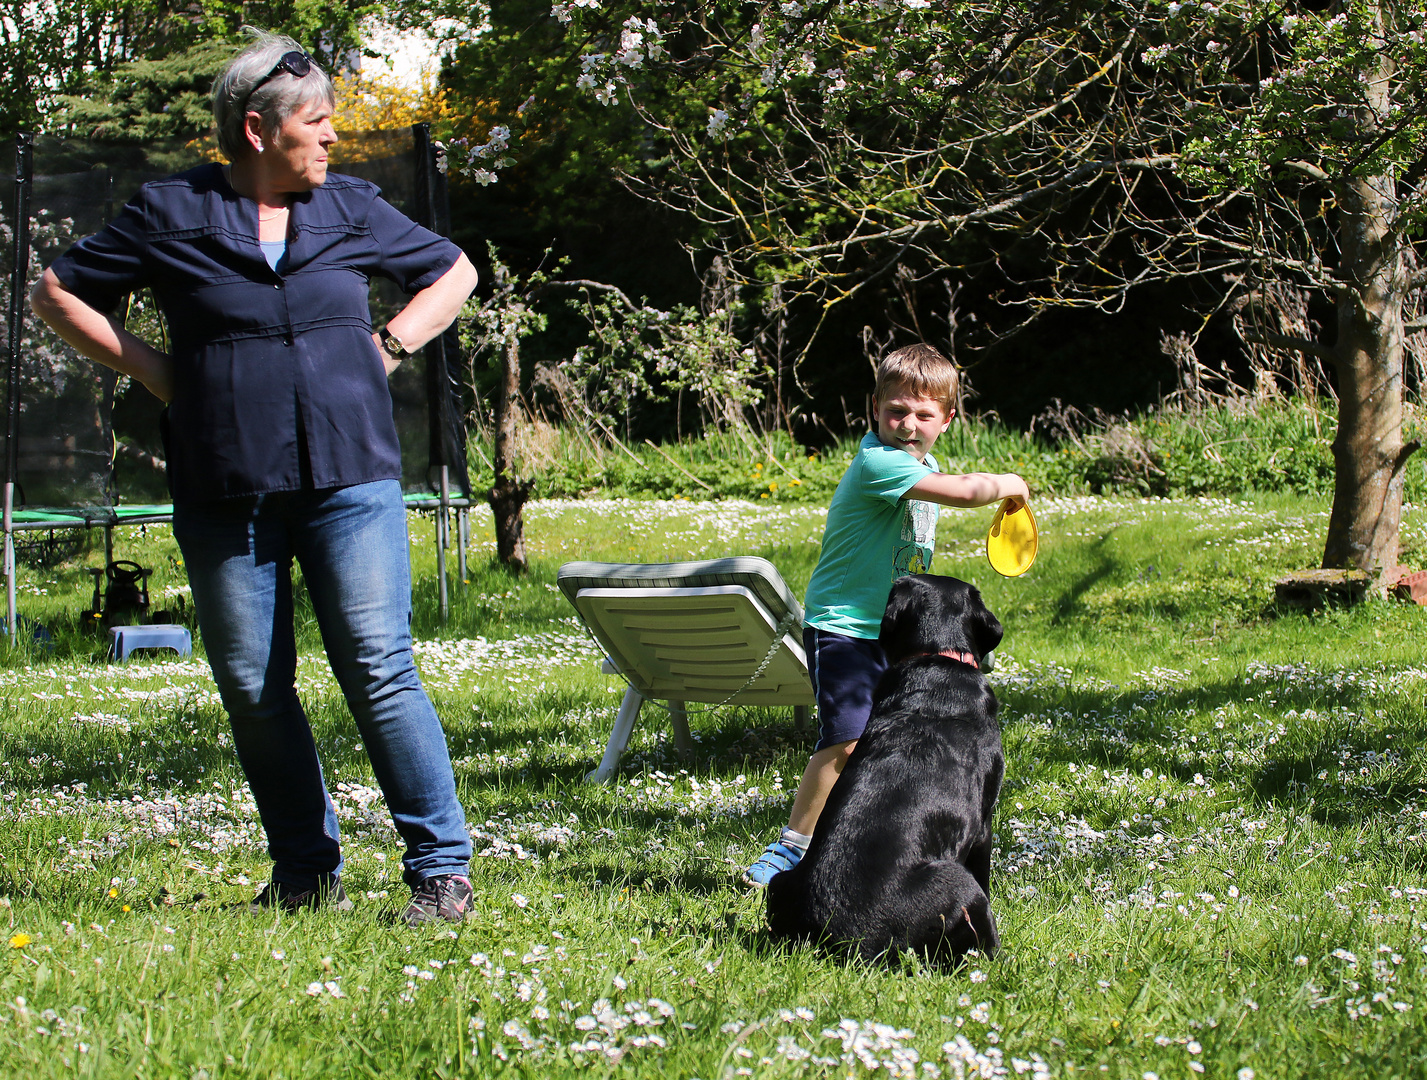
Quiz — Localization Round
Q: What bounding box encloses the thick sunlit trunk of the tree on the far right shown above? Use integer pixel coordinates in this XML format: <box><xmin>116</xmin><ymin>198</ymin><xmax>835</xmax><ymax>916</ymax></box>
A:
<box><xmin>1323</xmin><ymin>4</ymin><xmax>1417</xmax><ymax>592</ymax></box>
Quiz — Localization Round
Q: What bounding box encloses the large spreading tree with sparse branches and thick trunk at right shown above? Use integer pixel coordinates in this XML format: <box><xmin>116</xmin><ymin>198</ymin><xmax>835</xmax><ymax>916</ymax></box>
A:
<box><xmin>536</xmin><ymin>0</ymin><xmax>1427</xmax><ymax>576</ymax></box>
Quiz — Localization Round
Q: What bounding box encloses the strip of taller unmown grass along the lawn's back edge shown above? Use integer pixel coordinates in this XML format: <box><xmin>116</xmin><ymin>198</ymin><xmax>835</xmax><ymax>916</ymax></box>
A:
<box><xmin>471</xmin><ymin>398</ymin><xmax>1427</xmax><ymax>504</ymax></box>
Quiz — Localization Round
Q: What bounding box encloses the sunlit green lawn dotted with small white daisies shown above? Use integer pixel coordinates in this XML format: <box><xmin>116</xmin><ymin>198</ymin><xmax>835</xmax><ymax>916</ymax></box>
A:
<box><xmin>0</xmin><ymin>496</ymin><xmax>1427</xmax><ymax>1080</ymax></box>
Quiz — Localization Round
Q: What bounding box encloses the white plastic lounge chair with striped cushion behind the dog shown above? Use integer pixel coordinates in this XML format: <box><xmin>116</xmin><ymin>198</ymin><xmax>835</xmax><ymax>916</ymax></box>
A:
<box><xmin>557</xmin><ymin>556</ymin><xmax>816</xmax><ymax>783</ymax></box>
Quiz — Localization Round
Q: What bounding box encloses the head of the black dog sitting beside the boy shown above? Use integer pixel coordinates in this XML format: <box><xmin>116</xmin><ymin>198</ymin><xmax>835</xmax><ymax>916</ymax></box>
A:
<box><xmin>878</xmin><ymin>574</ymin><xmax>1002</xmax><ymax>663</ymax></box>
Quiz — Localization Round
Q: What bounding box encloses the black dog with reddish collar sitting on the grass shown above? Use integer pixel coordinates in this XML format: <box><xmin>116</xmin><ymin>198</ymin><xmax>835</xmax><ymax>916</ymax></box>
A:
<box><xmin>768</xmin><ymin>574</ymin><xmax>1006</xmax><ymax>959</ymax></box>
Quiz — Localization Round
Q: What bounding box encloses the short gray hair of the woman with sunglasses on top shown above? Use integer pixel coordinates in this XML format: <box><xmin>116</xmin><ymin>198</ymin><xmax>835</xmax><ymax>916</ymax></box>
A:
<box><xmin>213</xmin><ymin>26</ymin><xmax>337</xmax><ymax>161</ymax></box>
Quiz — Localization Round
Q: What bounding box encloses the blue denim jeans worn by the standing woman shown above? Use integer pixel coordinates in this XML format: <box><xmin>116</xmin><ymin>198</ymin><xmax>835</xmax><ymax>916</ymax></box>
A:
<box><xmin>174</xmin><ymin>479</ymin><xmax>471</xmax><ymax>889</ymax></box>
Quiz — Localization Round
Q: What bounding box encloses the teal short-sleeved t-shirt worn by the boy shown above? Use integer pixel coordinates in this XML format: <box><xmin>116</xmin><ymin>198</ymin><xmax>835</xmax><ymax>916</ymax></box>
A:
<box><xmin>803</xmin><ymin>434</ymin><xmax>939</xmax><ymax>638</ymax></box>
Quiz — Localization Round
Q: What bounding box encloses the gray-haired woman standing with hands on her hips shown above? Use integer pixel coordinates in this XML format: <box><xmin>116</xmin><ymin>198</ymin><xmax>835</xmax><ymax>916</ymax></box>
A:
<box><xmin>31</xmin><ymin>31</ymin><xmax>475</xmax><ymax>926</ymax></box>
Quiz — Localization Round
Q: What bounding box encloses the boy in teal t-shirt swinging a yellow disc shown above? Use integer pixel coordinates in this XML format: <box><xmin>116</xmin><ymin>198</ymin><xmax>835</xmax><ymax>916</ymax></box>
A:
<box><xmin>743</xmin><ymin>345</ymin><xmax>1030</xmax><ymax>887</ymax></box>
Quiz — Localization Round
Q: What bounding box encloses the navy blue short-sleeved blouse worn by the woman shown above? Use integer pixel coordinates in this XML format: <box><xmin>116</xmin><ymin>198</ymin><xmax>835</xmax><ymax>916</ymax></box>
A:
<box><xmin>51</xmin><ymin>164</ymin><xmax>461</xmax><ymax>502</ymax></box>
